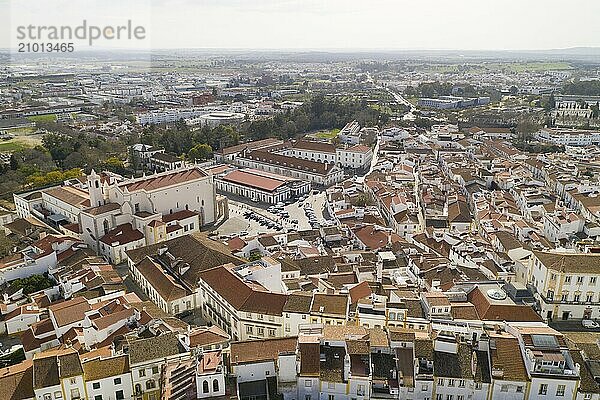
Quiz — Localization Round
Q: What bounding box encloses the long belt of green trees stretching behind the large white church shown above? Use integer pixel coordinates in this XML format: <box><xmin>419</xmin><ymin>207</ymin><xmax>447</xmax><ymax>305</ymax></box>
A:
<box><xmin>0</xmin><ymin>95</ymin><xmax>389</xmax><ymax>198</ymax></box>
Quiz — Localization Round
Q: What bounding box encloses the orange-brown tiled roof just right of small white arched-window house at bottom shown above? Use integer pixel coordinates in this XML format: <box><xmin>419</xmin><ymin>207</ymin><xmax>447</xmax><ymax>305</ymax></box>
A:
<box><xmin>231</xmin><ymin>337</ymin><xmax>298</xmax><ymax>365</ymax></box>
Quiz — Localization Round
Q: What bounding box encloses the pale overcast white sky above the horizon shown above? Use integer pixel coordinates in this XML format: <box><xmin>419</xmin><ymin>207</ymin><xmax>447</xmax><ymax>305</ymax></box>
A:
<box><xmin>0</xmin><ymin>0</ymin><xmax>600</xmax><ymax>50</ymax></box>
